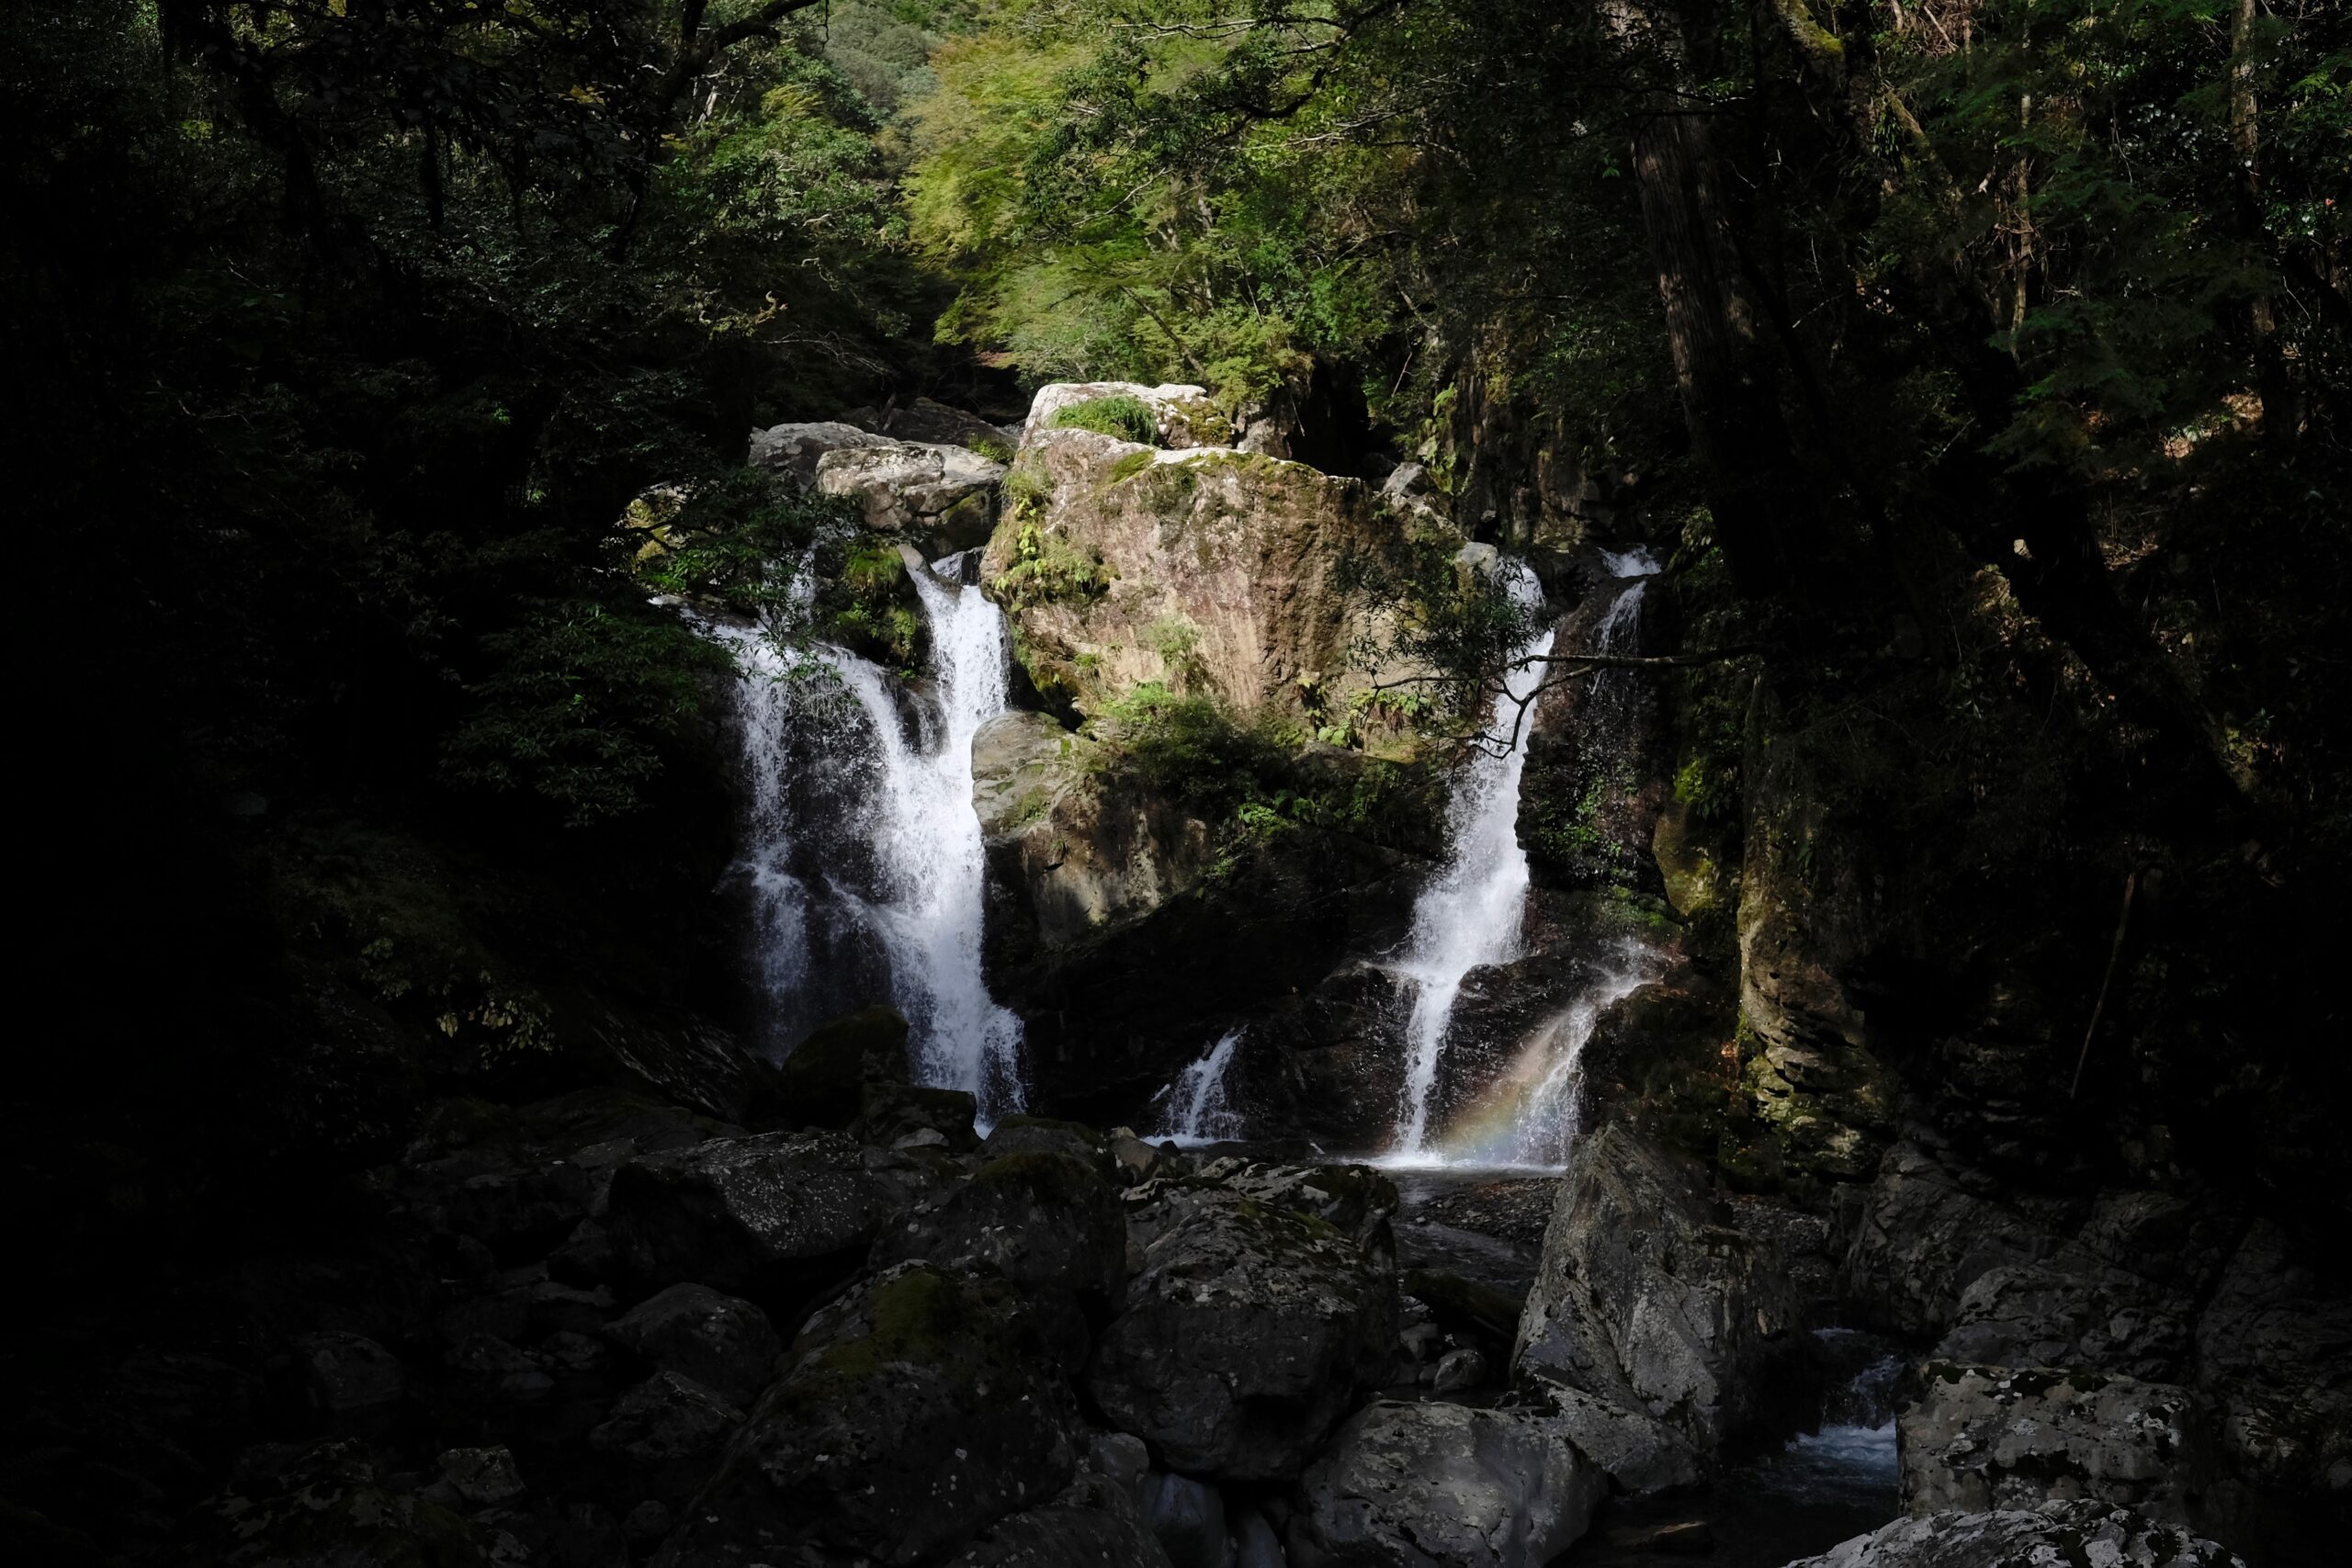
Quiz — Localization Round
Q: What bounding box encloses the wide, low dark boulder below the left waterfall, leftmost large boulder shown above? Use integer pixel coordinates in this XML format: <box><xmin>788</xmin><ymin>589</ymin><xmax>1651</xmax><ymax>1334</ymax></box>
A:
<box><xmin>605</xmin><ymin>1134</ymin><xmax>927</xmax><ymax>1288</ymax></box>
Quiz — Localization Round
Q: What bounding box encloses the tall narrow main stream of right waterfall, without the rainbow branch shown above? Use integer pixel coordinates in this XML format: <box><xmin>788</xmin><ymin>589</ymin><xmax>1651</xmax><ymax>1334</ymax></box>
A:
<box><xmin>1395</xmin><ymin>562</ymin><xmax>1553</xmax><ymax>1159</ymax></box>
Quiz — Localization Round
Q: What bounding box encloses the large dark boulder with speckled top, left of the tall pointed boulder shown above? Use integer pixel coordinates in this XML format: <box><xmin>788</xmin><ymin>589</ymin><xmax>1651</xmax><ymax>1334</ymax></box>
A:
<box><xmin>1087</xmin><ymin>1182</ymin><xmax>1397</xmax><ymax>1481</ymax></box>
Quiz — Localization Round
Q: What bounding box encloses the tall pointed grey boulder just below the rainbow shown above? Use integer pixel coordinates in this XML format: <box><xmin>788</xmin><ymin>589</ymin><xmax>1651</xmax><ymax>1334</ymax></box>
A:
<box><xmin>1517</xmin><ymin>1123</ymin><xmax>1799</xmax><ymax>1455</ymax></box>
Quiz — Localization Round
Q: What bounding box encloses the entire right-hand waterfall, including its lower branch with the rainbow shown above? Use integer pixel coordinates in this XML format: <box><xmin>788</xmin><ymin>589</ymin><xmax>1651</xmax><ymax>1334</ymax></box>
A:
<box><xmin>1390</xmin><ymin>547</ymin><xmax>1658</xmax><ymax>1164</ymax></box>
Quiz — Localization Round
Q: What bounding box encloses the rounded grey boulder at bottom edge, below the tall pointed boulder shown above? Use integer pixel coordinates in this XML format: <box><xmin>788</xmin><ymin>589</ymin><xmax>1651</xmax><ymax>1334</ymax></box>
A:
<box><xmin>1289</xmin><ymin>1401</ymin><xmax>1606</xmax><ymax>1568</ymax></box>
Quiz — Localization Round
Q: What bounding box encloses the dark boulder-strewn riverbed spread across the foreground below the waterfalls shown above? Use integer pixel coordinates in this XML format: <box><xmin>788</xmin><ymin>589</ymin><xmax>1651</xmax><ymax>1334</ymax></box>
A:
<box><xmin>9</xmin><ymin>1013</ymin><xmax>2293</xmax><ymax>1568</ymax></box>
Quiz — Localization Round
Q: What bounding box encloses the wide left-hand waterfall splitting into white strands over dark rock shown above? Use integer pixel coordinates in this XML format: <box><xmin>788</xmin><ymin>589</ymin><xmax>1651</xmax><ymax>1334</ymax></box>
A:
<box><xmin>713</xmin><ymin>558</ymin><xmax>1023</xmax><ymax>1123</ymax></box>
